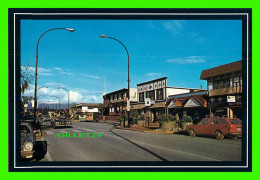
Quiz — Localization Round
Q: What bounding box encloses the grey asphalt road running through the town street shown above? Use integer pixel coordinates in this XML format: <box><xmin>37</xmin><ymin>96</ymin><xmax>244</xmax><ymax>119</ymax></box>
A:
<box><xmin>40</xmin><ymin>122</ymin><xmax>241</xmax><ymax>161</ymax></box>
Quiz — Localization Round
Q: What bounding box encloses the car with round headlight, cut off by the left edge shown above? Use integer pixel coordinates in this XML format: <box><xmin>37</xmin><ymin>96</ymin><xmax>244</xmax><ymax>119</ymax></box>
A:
<box><xmin>21</xmin><ymin>122</ymin><xmax>36</xmax><ymax>159</ymax></box>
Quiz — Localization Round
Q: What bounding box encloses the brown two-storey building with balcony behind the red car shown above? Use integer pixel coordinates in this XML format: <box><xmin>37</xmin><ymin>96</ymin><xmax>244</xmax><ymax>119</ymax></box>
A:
<box><xmin>200</xmin><ymin>60</ymin><xmax>242</xmax><ymax>118</ymax></box>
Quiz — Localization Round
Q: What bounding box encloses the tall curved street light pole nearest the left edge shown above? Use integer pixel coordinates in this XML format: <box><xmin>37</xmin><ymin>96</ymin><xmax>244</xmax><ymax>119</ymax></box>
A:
<box><xmin>34</xmin><ymin>28</ymin><xmax>75</xmax><ymax>126</ymax></box>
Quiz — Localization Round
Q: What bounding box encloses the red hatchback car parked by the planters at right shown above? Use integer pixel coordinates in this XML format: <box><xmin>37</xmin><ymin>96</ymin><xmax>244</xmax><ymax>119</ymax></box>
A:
<box><xmin>187</xmin><ymin>117</ymin><xmax>242</xmax><ymax>139</ymax></box>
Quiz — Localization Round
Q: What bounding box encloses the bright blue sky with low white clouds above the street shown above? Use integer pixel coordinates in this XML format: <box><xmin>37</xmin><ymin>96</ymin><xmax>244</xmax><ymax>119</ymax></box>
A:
<box><xmin>21</xmin><ymin>19</ymin><xmax>242</xmax><ymax>103</ymax></box>
